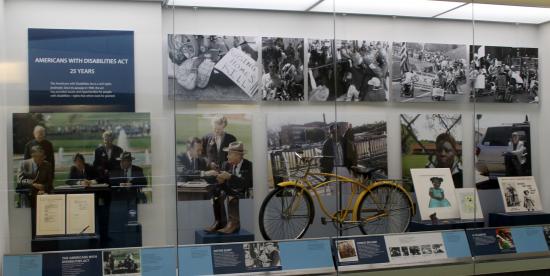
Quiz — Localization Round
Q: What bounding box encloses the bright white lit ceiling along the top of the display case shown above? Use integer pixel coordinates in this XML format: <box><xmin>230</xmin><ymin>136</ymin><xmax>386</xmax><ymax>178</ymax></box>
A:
<box><xmin>168</xmin><ymin>0</ymin><xmax>550</xmax><ymax>24</ymax></box>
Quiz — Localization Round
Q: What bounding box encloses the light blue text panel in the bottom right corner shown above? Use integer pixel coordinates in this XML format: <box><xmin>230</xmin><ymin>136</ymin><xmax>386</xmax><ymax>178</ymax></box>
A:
<box><xmin>511</xmin><ymin>226</ymin><xmax>548</xmax><ymax>253</ymax></box>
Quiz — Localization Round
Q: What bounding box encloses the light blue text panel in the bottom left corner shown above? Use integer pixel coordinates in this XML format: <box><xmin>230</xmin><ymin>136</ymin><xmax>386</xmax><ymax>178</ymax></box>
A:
<box><xmin>2</xmin><ymin>255</ymin><xmax>42</xmax><ymax>276</ymax></box>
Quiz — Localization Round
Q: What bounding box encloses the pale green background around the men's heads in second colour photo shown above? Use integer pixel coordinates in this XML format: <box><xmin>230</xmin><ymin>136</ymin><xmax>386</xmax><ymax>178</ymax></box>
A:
<box><xmin>176</xmin><ymin>114</ymin><xmax>253</xmax><ymax>157</ymax></box>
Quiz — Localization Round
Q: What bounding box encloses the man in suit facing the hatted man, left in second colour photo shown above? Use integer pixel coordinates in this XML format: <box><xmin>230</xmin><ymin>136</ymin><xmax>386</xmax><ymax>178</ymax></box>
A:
<box><xmin>176</xmin><ymin>137</ymin><xmax>208</xmax><ymax>182</ymax></box>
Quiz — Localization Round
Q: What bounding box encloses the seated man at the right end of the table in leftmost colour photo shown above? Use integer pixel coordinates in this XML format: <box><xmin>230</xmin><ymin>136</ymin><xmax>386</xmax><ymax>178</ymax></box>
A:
<box><xmin>109</xmin><ymin>151</ymin><xmax>147</xmax><ymax>188</ymax></box>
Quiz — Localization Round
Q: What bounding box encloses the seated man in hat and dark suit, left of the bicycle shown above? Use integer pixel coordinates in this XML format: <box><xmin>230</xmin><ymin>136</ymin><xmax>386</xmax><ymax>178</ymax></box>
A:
<box><xmin>206</xmin><ymin>141</ymin><xmax>253</xmax><ymax>234</ymax></box>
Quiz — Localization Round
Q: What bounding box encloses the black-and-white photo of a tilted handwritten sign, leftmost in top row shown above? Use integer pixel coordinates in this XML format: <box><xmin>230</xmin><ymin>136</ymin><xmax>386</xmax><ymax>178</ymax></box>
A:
<box><xmin>168</xmin><ymin>34</ymin><xmax>261</xmax><ymax>102</ymax></box>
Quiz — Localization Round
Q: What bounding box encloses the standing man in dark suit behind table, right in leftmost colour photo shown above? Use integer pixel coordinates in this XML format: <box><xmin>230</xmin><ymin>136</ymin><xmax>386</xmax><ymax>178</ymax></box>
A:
<box><xmin>93</xmin><ymin>130</ymin><xmax>123</xmax><ymax>183</ymax></box>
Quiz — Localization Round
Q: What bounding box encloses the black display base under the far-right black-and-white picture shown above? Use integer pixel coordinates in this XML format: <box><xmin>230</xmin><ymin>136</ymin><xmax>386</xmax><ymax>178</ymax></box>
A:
<box><xmin>489</xmin><ymin>212</ymin><xmax>550</xmax><ymax>227</ymax></box>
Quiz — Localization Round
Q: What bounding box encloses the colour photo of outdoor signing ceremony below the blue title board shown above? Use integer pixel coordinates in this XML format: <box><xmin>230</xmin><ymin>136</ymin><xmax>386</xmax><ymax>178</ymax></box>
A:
<box><xmin>12</xmin><ymin>113</ymin><xmax>152</xmax><ymax>207</ymax></box>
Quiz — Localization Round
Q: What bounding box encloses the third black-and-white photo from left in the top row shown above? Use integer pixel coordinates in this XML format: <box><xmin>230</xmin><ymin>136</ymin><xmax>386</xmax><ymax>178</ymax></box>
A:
<box><xmin>308</xmin><ymin>40</ymin><xmax>390</xmax><ymax>102</ymax></box>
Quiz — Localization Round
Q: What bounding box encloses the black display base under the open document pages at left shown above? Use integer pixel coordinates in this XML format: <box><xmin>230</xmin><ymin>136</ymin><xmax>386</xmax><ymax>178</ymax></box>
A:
<box><xmin>31</xmin><ymin>235</ymin><xmax>99</xmax><ymax>252</ymax></box>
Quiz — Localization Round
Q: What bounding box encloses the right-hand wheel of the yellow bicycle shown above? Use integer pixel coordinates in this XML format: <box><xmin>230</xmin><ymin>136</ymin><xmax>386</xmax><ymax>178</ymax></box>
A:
<box><xmin>356</xmin><ymin>183</ymin><xmax>413</xmax><ymax>235</ymax></box>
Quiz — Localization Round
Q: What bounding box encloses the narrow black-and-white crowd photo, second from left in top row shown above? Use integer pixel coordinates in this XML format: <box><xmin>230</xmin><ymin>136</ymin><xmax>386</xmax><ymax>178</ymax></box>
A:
<box><xmin>260</xmin><ymin>37</ymin><xmax>304</xmax><ymax>101</ymax></box>
